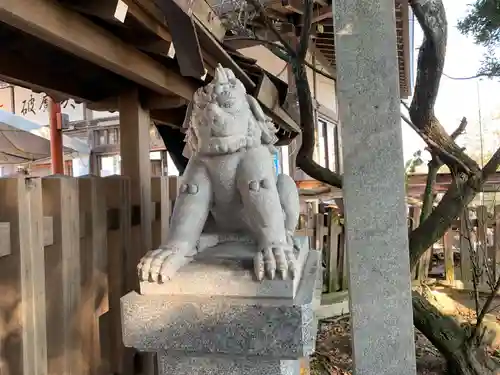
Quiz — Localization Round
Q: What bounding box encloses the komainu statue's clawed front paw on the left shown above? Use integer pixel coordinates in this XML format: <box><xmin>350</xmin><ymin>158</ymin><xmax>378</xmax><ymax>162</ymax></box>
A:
<box><xmin>137</xmin><ymin>246</ymin><xmax>192</xmax><ymax>283</ymax></box>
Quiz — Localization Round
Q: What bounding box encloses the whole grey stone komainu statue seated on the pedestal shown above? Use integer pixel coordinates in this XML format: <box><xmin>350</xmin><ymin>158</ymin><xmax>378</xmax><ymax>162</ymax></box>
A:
<box><xmin>138</xmin><ymin>65</ymin><xmax>299</xmax><ymax>281</ymax></box>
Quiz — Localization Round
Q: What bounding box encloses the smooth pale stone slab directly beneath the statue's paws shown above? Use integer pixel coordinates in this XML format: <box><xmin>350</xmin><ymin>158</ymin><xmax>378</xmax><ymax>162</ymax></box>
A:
<box><xmin>140</xmin><ymin>237</ymin><xmax>309</xmax><ymax>298</ymax></box>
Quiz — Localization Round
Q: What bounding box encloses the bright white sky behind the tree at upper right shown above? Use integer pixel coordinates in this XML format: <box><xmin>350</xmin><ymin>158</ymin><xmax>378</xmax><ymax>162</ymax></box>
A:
<box><xmin>403</xmin><ymin>0</ymin><xmax>500</xmax><ymax>160</ymax></box>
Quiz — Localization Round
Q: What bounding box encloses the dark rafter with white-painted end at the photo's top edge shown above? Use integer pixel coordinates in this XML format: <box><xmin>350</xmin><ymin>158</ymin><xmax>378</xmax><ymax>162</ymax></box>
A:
<box><xmin>59</xmin><ymin>0</ymin><xmax>128</xmax><ymax>23</ymax></box>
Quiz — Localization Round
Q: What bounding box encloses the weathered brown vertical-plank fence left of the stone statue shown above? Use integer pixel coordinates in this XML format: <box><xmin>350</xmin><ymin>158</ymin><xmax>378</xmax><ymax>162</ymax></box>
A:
<box><xmin>0</xmin><ymin>176</ymin><xmax>178</xmax><ymax>375</ymax></box>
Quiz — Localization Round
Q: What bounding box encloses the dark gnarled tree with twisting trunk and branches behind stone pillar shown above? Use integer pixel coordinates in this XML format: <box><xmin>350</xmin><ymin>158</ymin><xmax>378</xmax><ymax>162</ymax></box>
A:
<box><xmin>224</xmin><ymin>0</ymin><xmax>500</xmax><ymax>375</ymax></box>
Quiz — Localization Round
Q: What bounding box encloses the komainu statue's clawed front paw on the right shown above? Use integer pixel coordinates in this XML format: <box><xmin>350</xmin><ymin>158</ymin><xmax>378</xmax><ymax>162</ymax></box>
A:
<box><xmin>254</xmin><ymin>244</ymin><xmax>297</xmax><ymax>281</ymax></box>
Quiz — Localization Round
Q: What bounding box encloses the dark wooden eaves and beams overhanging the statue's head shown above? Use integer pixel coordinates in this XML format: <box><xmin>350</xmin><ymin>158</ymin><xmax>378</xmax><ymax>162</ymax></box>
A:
<box><xmin>0</xmin><ymin>0</ymin><xmax>299</xmax><ymax>139</ymax></box>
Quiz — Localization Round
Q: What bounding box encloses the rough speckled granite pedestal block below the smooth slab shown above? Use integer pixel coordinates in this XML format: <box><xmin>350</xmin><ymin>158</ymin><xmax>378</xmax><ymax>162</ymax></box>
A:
<box><xmin>121</xmin><ymin>245</ymin><xmax>321</xmax><ymax>375</ymax></box>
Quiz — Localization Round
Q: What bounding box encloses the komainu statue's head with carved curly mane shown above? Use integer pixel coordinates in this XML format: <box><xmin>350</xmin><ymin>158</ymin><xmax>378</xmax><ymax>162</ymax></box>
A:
<box><xmin>183</xmin><ymin>65</ymin><xmax>277</xmax><ymax>157</ymax></box>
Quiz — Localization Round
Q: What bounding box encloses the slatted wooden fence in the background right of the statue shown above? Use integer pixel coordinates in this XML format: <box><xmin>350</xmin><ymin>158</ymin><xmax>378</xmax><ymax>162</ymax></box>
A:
<box><xmin>297</xmin><ymin>205</ymin><xmax>500</xmax><ymax>293</ymax></box>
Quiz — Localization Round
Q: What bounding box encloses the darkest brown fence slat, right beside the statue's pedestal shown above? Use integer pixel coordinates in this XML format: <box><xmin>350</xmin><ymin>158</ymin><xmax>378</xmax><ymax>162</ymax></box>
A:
<box><xmin>103</xmin><ymin>176</ymin><xmax>133</xmax><ymax>375</ymax></box>
